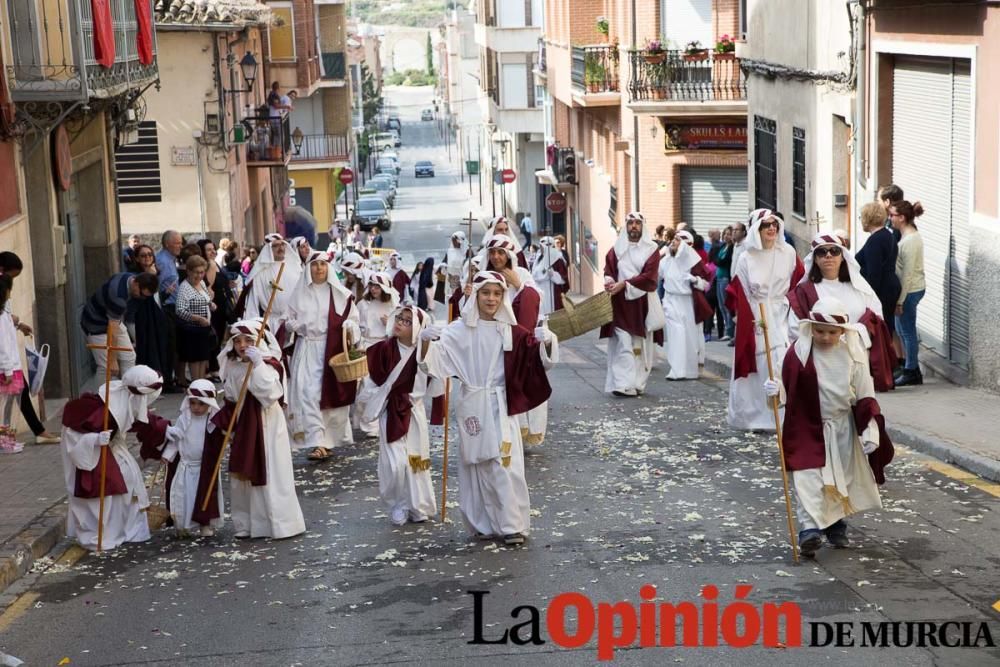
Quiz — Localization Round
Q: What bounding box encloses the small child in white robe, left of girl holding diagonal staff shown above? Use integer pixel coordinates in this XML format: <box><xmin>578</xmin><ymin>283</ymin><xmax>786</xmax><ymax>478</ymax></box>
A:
<box><xmin>162</xmin><ymin>380</ymin><xmax>223</xmax><ymax>537</ymax></box>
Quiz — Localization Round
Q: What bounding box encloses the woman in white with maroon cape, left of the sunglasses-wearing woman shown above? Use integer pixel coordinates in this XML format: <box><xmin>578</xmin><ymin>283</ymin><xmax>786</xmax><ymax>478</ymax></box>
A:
<box><xmin>726</xmin><ymin>208</ymin><xmax>805</xmax><ymax>431</ymax></box>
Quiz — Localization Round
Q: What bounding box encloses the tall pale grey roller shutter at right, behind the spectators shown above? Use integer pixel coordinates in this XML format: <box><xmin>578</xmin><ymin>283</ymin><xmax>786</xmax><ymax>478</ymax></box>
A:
<box><xmin>892</xmin><ymin>58</ymin><xmax>971</xmax><ymax>365</ymax></box>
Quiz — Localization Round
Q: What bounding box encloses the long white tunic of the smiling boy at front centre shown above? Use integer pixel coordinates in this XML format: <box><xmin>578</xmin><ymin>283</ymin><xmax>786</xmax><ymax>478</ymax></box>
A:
<box><xmin>422</xmin><ymin>320</ymin><xmax>554</xmax><ymax>535</ymax></box>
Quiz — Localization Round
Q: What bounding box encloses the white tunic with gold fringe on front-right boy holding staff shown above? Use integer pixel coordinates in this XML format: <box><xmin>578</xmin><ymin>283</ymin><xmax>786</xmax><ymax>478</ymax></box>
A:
<box><xmin>792</xmin><ymin>344</ymin><xmax>882</xmax><ymax>530</ymax></box>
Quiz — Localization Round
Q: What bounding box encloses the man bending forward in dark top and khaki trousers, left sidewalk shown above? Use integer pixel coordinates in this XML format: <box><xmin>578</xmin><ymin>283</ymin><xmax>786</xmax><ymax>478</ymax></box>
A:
<box><xmin>80</xmin><ymin>273</ymin><xmax>159</xmax><ymax>382</ymax></box>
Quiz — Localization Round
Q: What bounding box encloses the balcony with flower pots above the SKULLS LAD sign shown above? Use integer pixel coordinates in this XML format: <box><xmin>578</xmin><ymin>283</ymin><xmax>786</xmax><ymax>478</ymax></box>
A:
<box><xmin>628</xmin><ymin>51</ymin><xmax>747</xmax><ymax>116</ymax></box>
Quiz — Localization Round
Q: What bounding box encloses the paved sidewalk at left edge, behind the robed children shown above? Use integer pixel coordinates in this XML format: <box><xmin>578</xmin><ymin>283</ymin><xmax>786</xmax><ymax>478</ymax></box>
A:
<box><xmin>0</xmin><ymin>394</ymin><xmax>183</xmax><ymax>596</ymax></box>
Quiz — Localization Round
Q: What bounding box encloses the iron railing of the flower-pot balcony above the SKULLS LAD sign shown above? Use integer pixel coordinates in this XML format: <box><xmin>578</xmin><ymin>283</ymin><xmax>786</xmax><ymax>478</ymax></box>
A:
<box><xmin>628</xmin><ymin>51</ymin><xmax>747</xmax><ymax>102</ymax></box>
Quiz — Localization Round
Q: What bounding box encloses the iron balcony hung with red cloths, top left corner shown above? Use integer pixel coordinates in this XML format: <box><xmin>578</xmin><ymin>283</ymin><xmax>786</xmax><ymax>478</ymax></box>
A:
<box><xmin>7</xmin><ymin>0</ymin><xmax>159</xmax><ymax>103</ymax></box>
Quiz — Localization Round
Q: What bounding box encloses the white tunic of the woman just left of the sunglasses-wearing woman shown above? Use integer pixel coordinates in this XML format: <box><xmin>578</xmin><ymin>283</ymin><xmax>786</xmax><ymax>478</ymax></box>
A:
<box><xmin>728</xmin><ymin>248</ymin><xmax>796</xmax><ymax>431</ymax></box>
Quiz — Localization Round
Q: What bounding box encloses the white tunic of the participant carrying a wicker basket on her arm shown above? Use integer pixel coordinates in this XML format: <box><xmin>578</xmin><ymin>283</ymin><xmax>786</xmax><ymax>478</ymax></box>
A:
<box><xmin>286</xmin><ymin>283</ymin><xmax>359</xmax><ymax>449</ymax></box>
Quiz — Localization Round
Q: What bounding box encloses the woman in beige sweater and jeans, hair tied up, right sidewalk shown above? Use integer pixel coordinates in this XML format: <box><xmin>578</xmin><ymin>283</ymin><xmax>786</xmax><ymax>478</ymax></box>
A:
<box><xmin>889</xmin><ymin>199</ymin><xmax>925</xmax><ymax>387</ymax></box>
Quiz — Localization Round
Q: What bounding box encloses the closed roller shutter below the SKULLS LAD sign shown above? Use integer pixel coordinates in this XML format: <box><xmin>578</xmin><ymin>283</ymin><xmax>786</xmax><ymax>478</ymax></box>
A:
<box><xmin>681</xmin><ymin>167</ymin><xmax>749</xmax><ymax>234</ymax></box>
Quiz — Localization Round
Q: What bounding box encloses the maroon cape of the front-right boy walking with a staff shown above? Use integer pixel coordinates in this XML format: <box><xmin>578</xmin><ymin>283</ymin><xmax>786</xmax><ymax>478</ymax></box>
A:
<box><xmin>781</xmin><ymin>347</ymin><xmax>894</xmax><ymax>484</ymax></box>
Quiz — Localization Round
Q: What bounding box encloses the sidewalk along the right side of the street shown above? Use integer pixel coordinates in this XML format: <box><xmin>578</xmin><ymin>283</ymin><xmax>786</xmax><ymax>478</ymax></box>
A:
<box><xmin>700</xmin><ymin>341</ymin><xmax>1000</xmax><ymax>482</ymax></box>
